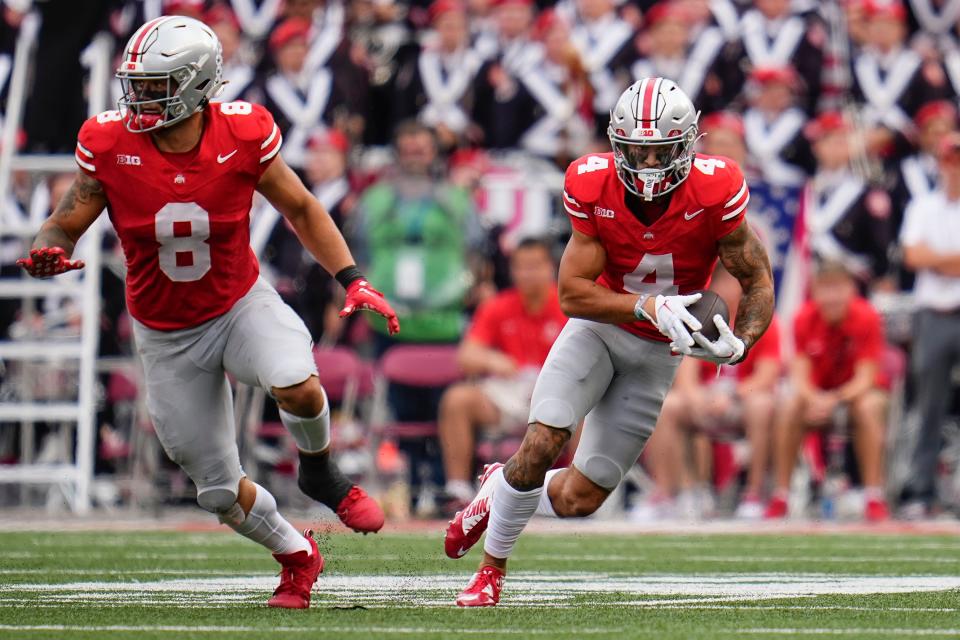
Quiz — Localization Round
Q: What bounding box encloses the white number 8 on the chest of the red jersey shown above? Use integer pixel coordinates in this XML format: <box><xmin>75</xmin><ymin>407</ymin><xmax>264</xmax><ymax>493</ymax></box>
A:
<box><xmin>154</xmin><ymin>202</ymin><xmax>210</xmax><ymax>282</ymax></box>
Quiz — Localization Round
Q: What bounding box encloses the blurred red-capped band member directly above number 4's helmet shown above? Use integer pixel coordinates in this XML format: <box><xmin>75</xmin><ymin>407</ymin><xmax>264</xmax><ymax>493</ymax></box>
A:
<box><xmin>630</xmin><ymin>2</ymin><xmax>724</xmax><ymax>109</ymax></box>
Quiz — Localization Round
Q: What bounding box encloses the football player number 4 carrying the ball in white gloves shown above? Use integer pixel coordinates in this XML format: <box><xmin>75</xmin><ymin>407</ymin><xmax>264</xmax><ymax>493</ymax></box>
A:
<box><xmin>445</xmin><ymin>78</ymin><xmax>773</xmax><ymax>607</ymax></box>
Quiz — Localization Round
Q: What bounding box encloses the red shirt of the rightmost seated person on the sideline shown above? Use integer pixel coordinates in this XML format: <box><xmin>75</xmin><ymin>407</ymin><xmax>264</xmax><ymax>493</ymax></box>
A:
<box><xmin>793</xmin><ymin>297</ymin><xmax>889</xmax><ymax>390</ymax></box>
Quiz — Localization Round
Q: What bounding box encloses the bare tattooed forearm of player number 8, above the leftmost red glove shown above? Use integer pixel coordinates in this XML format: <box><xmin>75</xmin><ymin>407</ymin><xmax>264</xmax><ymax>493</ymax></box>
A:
<box><xmin>33</xmin><ymin>171</ymin><xmax>107</xmax><ymax>257</ymax></box>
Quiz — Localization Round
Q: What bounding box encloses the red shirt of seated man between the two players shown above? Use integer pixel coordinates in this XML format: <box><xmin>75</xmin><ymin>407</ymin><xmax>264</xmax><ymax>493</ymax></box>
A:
<box><xmin>467</xmin><ymin>287</ymin><xmax>567</xmax><ymax>368</ymax></box>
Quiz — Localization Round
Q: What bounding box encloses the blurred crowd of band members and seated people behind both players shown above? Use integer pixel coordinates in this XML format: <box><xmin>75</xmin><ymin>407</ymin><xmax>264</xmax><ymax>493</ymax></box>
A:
<box><xmin>0</xmin><ymin>0</ymin><xmax>960</xmax><ymax>521</ymax></box>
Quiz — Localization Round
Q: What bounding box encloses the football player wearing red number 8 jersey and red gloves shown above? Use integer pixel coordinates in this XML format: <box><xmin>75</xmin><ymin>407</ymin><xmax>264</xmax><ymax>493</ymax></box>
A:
<box><xmin>20</xmin><ymin>16</ymin><xmax>399</xmax><ymax>608</ymax></box>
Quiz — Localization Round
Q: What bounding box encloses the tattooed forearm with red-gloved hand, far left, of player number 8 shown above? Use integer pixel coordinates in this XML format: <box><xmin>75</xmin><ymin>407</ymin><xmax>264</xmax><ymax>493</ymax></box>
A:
<box><xmin>17</xmin><ymin>172</ymin><xmax>107</xmax><ymax>278</ymax></box>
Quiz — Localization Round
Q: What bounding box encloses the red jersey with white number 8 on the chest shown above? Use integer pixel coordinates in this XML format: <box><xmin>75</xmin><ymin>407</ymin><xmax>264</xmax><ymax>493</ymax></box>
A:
<box><xmin>76</xmin><ymin>102</ymin><xmax>281</xmax><ymax>331</ymax></box>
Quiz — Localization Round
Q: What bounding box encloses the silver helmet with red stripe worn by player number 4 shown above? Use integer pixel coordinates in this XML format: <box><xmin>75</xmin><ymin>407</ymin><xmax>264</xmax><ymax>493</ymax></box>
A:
<box><xmin>607</xmin><ymin>78</ymin><xmax>700</xmax><ymax>200</ymax></box>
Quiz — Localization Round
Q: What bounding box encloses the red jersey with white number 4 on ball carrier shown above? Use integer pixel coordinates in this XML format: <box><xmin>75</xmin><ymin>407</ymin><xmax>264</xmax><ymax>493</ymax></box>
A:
<box><xmin>563</xmin><ymin>153</ymin><xmax>750</xmax><ymax>342</ymax></box>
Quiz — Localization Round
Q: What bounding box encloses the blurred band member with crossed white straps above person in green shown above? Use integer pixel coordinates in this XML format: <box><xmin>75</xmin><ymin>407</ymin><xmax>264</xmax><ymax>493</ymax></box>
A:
<box><xmin>394</xmin><ymin>0</ymin><xmax>483</xmax><ymax>149</ymax></box>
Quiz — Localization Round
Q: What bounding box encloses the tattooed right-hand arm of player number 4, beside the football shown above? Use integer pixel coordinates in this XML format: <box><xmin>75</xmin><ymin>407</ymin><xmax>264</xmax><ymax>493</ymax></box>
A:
<box><xmin>717</xmin><ymin>222</ymin><xmax>773</xmax><ymax>354</ymax></box>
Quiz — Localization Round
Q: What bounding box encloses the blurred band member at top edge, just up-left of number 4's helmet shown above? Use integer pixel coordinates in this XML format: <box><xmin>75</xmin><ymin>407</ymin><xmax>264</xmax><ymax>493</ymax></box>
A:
<box><xmin>570</xmin><ymin>0</ymin><xmax>637</xmax><ymax>138</ymax></box>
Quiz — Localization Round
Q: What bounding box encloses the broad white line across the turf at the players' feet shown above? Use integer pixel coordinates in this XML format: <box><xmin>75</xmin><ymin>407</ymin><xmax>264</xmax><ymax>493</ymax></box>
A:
<box><xmin>0</xmin><ymin>572</ymin><xmax>960</xmax><ymax>609</ymax></box>
